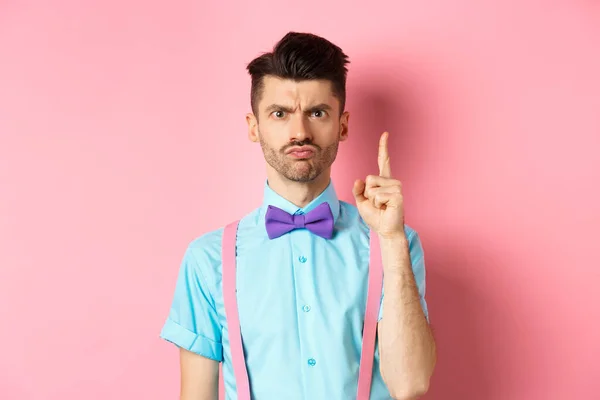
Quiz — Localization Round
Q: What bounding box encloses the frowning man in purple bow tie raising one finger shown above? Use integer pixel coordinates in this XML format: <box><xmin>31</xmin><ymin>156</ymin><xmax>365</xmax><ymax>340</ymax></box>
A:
<box><xmin>161</xmin><ymin>32</ymin><xmax>436</xmax><ymax>400</ymax></box>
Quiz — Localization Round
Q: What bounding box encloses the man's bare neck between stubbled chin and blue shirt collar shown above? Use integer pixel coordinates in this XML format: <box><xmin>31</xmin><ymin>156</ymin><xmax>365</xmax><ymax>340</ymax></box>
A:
<box><xmin>267</xmin><ymin>170</ymin><xmax>330</xmax><ymax>207</ymax></box>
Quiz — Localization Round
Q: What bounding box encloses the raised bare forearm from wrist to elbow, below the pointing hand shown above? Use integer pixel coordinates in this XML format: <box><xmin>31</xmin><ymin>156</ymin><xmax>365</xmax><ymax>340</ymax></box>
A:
<box><xmin>378</xmin><ymin>235</ymin><xmax>436</xmax><ymax>400</ymax></box>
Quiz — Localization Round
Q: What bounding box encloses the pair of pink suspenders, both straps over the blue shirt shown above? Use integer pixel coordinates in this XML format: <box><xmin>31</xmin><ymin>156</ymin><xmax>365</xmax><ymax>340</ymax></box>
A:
<box><xmin>220</xmin><ymin>221</ymin><xmax>383</xmax><ymax>400</ymax></box>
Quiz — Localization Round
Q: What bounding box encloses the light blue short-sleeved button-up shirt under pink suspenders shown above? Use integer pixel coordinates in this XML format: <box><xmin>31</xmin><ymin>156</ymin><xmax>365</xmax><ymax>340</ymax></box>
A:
<box><xmin>160</xmin><ymin>183</ymin><xmax>429</xmax><ymax>400</ymax></box>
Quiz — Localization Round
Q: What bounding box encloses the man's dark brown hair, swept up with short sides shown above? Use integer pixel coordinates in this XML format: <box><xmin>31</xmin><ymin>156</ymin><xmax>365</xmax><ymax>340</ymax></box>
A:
<box><xmin>247</xmin><ymin>32</ymin><xmax>349</xmax><ymax>116</ymax></box>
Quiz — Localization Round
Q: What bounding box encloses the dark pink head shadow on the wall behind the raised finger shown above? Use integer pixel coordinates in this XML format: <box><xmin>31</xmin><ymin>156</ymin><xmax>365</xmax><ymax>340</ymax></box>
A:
<box><xmin>333</xmin><ymin>66</ymin><xmax>428</xmax><ymax>203</ymax></box>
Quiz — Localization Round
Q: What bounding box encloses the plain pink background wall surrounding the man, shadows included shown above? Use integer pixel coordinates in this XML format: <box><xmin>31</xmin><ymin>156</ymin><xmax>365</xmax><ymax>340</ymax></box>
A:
<box><xmin>0</xmin><ymin>0</ymin><xmax>600</xmax><ymax>400</ymax></box>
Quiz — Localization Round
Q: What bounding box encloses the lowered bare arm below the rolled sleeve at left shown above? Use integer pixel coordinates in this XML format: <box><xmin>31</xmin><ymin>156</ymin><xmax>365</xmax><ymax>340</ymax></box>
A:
<box><xmin>179</xmin><ymin>348</ymin><xmax>219</xmax><ymax>400</ymax></box>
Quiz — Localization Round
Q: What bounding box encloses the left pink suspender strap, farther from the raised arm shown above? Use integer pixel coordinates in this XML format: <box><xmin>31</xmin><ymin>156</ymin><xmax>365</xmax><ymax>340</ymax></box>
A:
<box><xmin>221</xmin><ymin>221</ymin><xmax>250</xmax><ymax>400</ymax></box>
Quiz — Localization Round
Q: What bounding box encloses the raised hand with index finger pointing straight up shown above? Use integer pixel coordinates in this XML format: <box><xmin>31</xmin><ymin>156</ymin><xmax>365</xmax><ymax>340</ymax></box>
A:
<box><xmin>352</xmin><ymin>132</ymin><xmax>404</xmax><ymax>238</ymax></box>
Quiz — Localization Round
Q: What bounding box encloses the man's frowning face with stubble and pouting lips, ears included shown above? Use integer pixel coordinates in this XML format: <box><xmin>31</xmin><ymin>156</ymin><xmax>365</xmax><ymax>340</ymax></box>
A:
<box><xmin>247</xmin><ymin>76</ymin><xmax>348</xmax><ymax>182</ymax></box>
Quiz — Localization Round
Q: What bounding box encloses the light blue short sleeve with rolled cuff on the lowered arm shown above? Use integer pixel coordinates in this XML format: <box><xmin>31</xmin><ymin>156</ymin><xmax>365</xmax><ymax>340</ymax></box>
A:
<box><xmin>160</xmin><ymin>242</ymin><xmax>223</xmax><ymax>361</ymax></box>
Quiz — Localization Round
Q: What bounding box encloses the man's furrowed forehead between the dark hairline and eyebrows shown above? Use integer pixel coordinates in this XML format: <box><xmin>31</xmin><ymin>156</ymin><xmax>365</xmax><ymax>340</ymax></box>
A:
<box><xmin>259</xmin><ymin>76</ymin><xmax>338</xmax><ymax>109</ymax></box>
